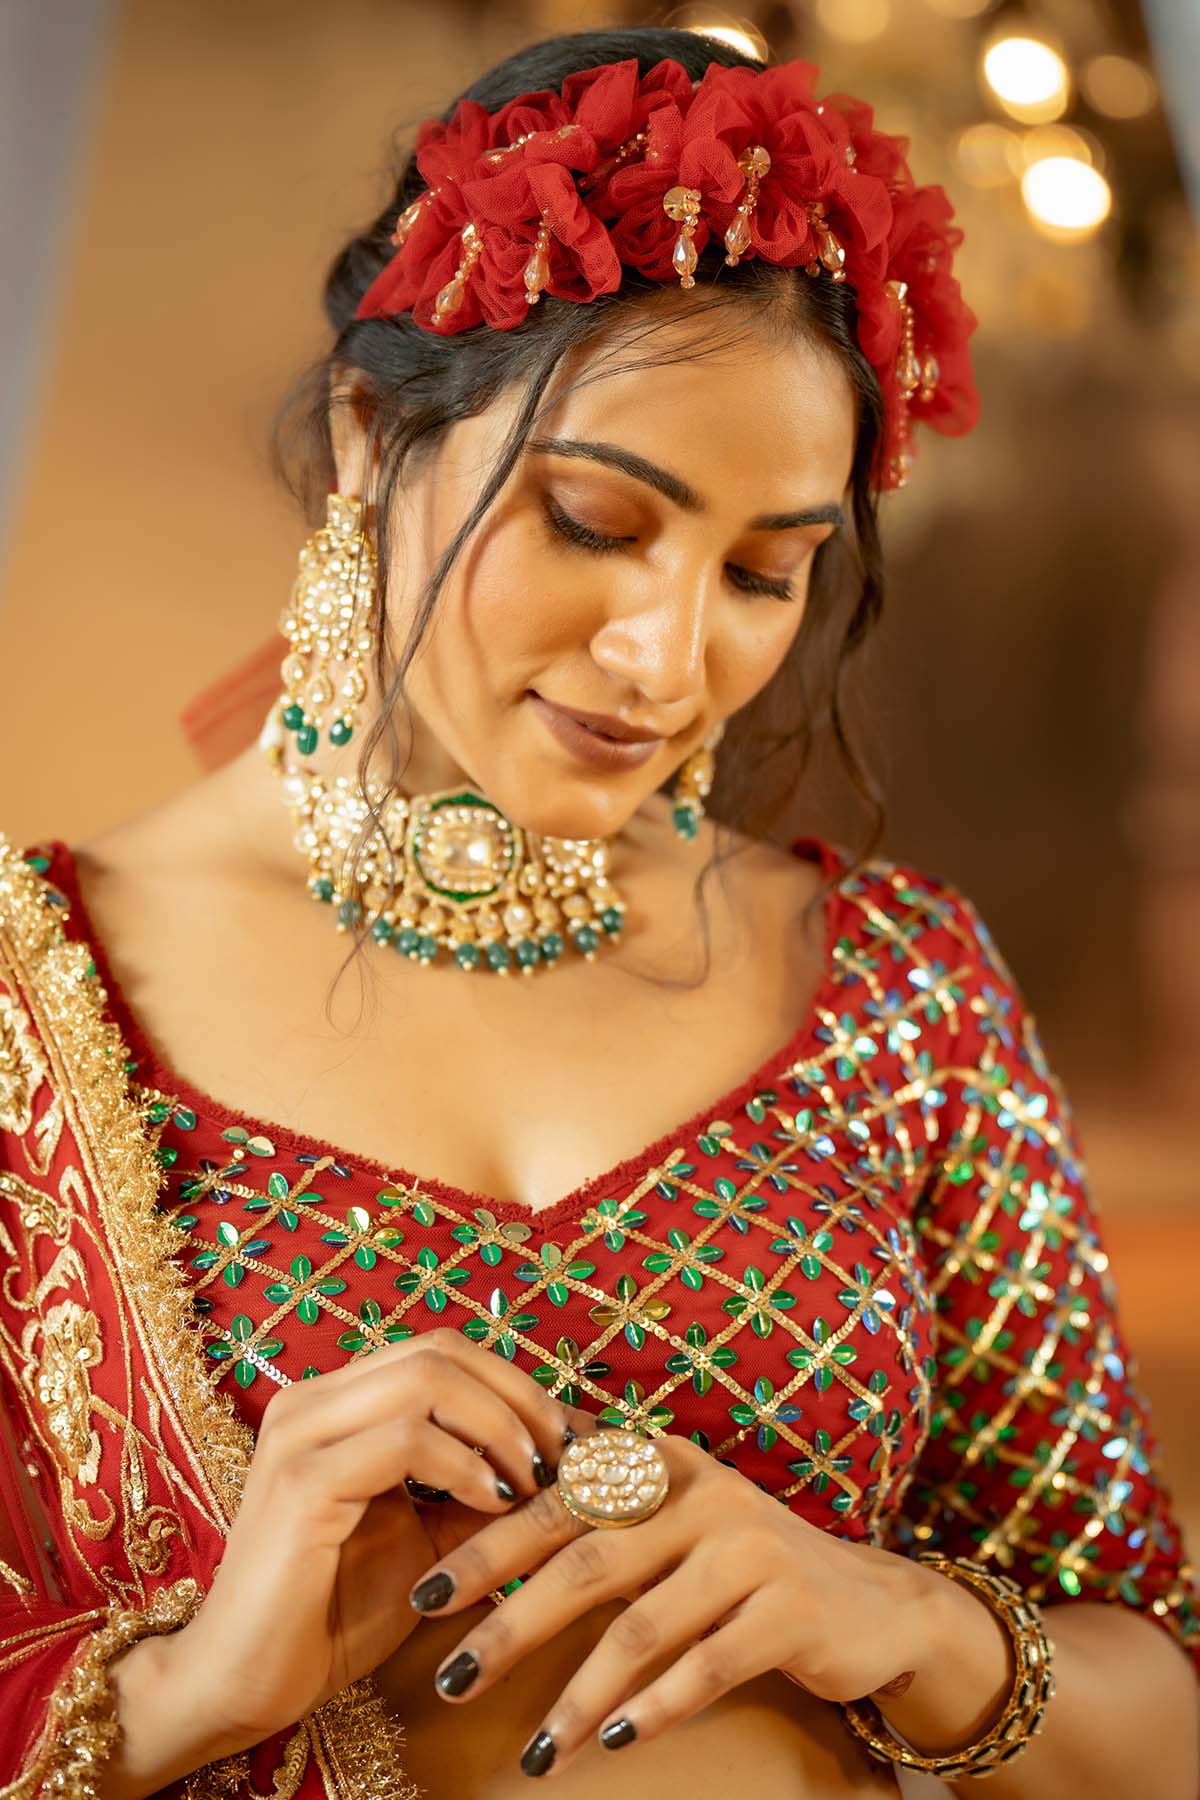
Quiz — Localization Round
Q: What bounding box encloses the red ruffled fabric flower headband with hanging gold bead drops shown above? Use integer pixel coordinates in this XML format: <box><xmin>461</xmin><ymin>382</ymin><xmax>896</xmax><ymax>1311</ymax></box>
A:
<box><xmin>354</xmin><ymin>58</ymin><xmax>979</xmax><ymax>490</ymax></box>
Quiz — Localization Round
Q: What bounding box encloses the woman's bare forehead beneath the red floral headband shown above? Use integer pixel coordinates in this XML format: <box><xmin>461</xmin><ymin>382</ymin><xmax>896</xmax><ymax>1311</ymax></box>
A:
<box><xmin>528</xmin><ymin>308</ymin><xmax>856</xmax><ymax>518</ymax></box>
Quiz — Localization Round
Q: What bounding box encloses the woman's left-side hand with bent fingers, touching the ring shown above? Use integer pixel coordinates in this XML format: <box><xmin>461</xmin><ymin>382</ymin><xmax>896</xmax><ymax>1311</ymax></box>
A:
<box><xmin>169</xmin><ymin>1328</ymin><xmax>570</xmax><ymax>1755</ymax></box>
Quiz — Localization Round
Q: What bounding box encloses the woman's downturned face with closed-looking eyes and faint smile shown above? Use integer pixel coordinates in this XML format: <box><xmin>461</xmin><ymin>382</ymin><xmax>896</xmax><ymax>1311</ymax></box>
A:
<box><xmin>338</xmin><ymin>309</ymin><xmax>855</xmax><ymax>837</ymax></box>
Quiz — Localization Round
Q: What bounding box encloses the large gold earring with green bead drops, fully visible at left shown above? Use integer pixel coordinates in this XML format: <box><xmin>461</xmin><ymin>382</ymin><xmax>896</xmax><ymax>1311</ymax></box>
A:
<box><xmin>279</xmin><ymin>493</ymin><xmax>376</xmax><ymax>756</ymax></box>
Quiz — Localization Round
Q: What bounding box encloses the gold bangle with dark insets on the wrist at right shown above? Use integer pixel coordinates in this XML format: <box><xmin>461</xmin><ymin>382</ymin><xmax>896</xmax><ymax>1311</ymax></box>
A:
<box><xmin>842</xmin><ymin>1550</ymin><xmax>1054</xmax><ymax>1780</ymax></box>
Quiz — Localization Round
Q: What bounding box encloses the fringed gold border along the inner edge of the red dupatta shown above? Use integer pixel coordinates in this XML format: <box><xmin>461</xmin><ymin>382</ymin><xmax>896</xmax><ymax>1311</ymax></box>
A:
<box><xmin>0</xmin><ymin>832</ymin><xmax>419</xmax><ymax>1800</ymax></box>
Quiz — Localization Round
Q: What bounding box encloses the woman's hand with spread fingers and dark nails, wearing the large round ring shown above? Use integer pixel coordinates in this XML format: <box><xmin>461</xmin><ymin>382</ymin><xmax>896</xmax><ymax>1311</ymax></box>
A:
<box><xmin>402</xmin><ymin>1436</ymin><xmax>946</xmax><ymax>1775</ymax></box>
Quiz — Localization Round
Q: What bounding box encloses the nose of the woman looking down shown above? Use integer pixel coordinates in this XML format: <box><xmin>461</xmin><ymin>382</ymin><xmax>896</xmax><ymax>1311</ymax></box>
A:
<box><xmin>590</xmin><ymin>571</ymin><xmax>714</xmax><ymax>709</ymax></box>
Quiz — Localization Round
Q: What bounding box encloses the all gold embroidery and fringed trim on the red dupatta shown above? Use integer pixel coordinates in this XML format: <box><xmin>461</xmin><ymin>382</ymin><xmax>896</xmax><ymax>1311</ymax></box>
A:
<box><xmin>0</xmin><ymin>833</ymin><xmax>419</xmax><ymax>1800</ymax></box>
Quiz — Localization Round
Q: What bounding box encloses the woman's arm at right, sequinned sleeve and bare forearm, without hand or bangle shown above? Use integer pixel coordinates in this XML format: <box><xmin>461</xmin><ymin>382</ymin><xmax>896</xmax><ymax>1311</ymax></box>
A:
<box><xmin>878</xmin><ymin>900</ymin><xmax>1200</xmax><ymax>1800</ymax></box>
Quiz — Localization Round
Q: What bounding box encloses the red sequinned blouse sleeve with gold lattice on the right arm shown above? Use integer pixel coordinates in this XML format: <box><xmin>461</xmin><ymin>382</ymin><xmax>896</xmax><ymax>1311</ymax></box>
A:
<box><xmin>898</xmin><ymin>895</ymin><xmax>1200</xmax><ymax>1667</ymax></box>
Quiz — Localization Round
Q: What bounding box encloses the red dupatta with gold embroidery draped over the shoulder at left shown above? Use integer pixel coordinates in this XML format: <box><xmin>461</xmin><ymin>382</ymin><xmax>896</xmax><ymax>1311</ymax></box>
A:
<box><xmin>0</xmin><ymin>837</ymin><xmax>417</xmax><ymax>1800</ymax></box>
